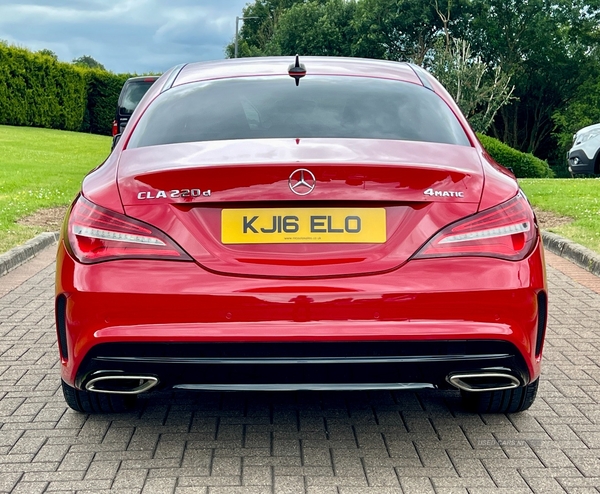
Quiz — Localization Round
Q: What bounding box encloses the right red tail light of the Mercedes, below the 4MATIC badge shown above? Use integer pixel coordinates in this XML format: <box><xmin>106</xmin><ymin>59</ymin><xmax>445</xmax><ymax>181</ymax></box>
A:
<box><xmin>414</xmin><ymin>193</ymin><xmax>538</xmax><ymax>261</ymax></box>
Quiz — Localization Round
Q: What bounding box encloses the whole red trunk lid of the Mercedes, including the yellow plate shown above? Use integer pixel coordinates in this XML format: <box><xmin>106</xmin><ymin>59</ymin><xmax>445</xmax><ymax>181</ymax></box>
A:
<box><xmin>118</xmin><ymin>139</ymin><xmax>483</xmax><ymax>278</ymax></box>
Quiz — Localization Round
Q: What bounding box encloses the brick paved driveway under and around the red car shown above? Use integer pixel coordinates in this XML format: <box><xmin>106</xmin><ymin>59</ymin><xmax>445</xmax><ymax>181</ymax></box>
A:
<box><xmin>0</xmin><ymin>251</ymin><xmax>600</xmax><ymax>494</ymax></box>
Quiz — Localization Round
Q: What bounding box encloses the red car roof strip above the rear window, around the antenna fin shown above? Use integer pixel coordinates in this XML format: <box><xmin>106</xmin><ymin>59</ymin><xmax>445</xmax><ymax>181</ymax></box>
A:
<box><xmin>173</xmin><ymin>56</ymin><xmax>423</xmax><ymax>86</ymax></box>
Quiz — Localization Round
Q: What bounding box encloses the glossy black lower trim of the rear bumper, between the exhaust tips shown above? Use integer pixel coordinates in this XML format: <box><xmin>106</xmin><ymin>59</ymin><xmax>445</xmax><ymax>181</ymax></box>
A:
<box><xmin>75</xmin><ymin>340</ymin><xmax>530</xmax><ymax>389</ymax></box>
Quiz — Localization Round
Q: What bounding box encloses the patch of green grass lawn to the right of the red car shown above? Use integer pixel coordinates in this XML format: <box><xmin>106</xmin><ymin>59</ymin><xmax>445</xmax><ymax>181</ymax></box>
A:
<box><xmin>519</xmin><ymin>178</ymin><xmax>600</xmax><ymax>253</ymax></box>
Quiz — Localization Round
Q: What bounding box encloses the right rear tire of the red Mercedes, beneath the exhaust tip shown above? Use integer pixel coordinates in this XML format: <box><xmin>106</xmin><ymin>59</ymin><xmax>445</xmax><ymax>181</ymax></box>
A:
<box><xmin>460</xmin><ymin>379</ymin><xmax>539</xmax><ymax>413</ymax></box>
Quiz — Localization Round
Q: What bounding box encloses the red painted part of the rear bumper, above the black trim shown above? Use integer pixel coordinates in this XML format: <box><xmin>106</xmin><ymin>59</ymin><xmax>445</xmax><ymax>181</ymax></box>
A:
<box><xmin>57</xmin><ymin>238</ymin><xmax>546</xmax><ymax>384</ymax></box>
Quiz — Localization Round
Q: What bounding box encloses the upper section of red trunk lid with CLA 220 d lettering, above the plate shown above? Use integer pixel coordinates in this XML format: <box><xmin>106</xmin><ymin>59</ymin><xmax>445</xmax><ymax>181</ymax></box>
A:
<box><xmin>119</xmin><ymin>139</ymin><xmax>482</xmax><ymax>206</ymax></box>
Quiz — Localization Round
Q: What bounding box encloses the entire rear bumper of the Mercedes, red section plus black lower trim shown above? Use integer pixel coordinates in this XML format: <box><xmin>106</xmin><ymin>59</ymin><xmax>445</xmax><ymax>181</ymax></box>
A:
<box><xmin>56</xmin><ymin>243</ymin><xmax>546</xmax><ymax>389</ymax></box>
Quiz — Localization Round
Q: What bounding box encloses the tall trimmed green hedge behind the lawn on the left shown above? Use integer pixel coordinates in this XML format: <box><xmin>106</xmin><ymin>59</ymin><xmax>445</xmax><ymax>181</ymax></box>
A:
<box><xmin>0</xmin><ymin>41</ymin><xmax>137</xmax><ymax>135</ymax></box>
